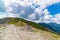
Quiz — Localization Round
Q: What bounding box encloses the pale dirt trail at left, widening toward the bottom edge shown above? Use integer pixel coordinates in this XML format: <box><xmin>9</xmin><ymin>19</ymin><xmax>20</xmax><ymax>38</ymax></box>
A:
<box><xmin>2</xmin><ymin>25</ymin><xmax>21</xmax><ymax>40</ymax></box>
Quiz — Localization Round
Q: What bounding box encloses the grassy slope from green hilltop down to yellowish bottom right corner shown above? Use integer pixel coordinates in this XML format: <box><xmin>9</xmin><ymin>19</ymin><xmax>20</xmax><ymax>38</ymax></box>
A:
<box><xmin>2</xmin><ymin>18</ymin><xmax>60</xmax><ymax>40</ymax></box>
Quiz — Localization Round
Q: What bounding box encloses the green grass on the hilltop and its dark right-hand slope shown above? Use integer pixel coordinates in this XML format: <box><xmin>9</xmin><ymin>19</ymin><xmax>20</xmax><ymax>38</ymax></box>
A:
<box><xmin>4</xmin><ymin>18</ymin><xmax>48</xmax><ymax>31</ymax></box>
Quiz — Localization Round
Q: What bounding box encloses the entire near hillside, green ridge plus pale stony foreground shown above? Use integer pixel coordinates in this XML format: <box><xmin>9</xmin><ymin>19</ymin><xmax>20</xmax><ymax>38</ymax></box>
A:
<box><xmin>0</xmin><ymin>17</ymin><xmax>60</xmax><ymax>40</ymax></box>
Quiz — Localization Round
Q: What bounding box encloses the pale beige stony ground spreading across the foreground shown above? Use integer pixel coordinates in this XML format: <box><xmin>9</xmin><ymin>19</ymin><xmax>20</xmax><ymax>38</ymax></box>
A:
<box><xmin>0</xmin><ymin>25</ymin><xmax>51</xmax><ymax>40</ymax></box>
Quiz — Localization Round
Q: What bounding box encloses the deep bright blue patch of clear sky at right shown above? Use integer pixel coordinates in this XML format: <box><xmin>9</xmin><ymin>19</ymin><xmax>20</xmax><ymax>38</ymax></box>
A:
<box><xmin>47</xmin><ymin>3</ymin><xmax>60</xmax><ymax>15</ymax></box>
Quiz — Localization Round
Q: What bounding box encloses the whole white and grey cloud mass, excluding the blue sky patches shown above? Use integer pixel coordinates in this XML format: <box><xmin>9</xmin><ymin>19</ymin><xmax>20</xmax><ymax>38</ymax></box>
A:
<box><xmin>3</xmin><ymin>0</ymin><xmax>60</xmax><ymax>24</ymax></box>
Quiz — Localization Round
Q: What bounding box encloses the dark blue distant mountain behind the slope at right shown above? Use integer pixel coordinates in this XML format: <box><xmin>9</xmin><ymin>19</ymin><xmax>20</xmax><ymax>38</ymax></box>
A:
<box><xmin>39</xmin><ymin>23</ymin><xmax>60</xmax><ymax>34</ymax></box>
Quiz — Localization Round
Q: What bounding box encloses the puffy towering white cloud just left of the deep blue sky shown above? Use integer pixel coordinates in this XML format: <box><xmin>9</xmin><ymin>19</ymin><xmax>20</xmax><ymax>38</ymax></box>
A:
<box><xmin>35</xmin><ymin>9</ymin><xmax>53</xmax><ymax>23</ymax></box>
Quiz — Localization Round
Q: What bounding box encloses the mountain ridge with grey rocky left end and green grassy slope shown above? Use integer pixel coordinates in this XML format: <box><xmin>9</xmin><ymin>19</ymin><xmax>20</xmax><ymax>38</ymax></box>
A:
<box><xmin>1</xmin><ymin>17</ymin><xmax>48</xmax><ymax>31</ymax></box>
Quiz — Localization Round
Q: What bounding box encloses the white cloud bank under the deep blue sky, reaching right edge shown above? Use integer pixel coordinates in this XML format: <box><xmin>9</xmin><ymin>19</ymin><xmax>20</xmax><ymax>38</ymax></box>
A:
<box><xmin>35</xmin><ymin>9</ymin><xmax>60</xmax><ymax>24</ymax></box>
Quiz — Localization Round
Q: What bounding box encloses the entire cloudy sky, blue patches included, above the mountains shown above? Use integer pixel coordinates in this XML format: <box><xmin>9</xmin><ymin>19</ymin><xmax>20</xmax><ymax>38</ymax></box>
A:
<box><xmin>0</xmin><ymin>0</ymin><xmax>60</xmax><ymax>24</ymax></box>
